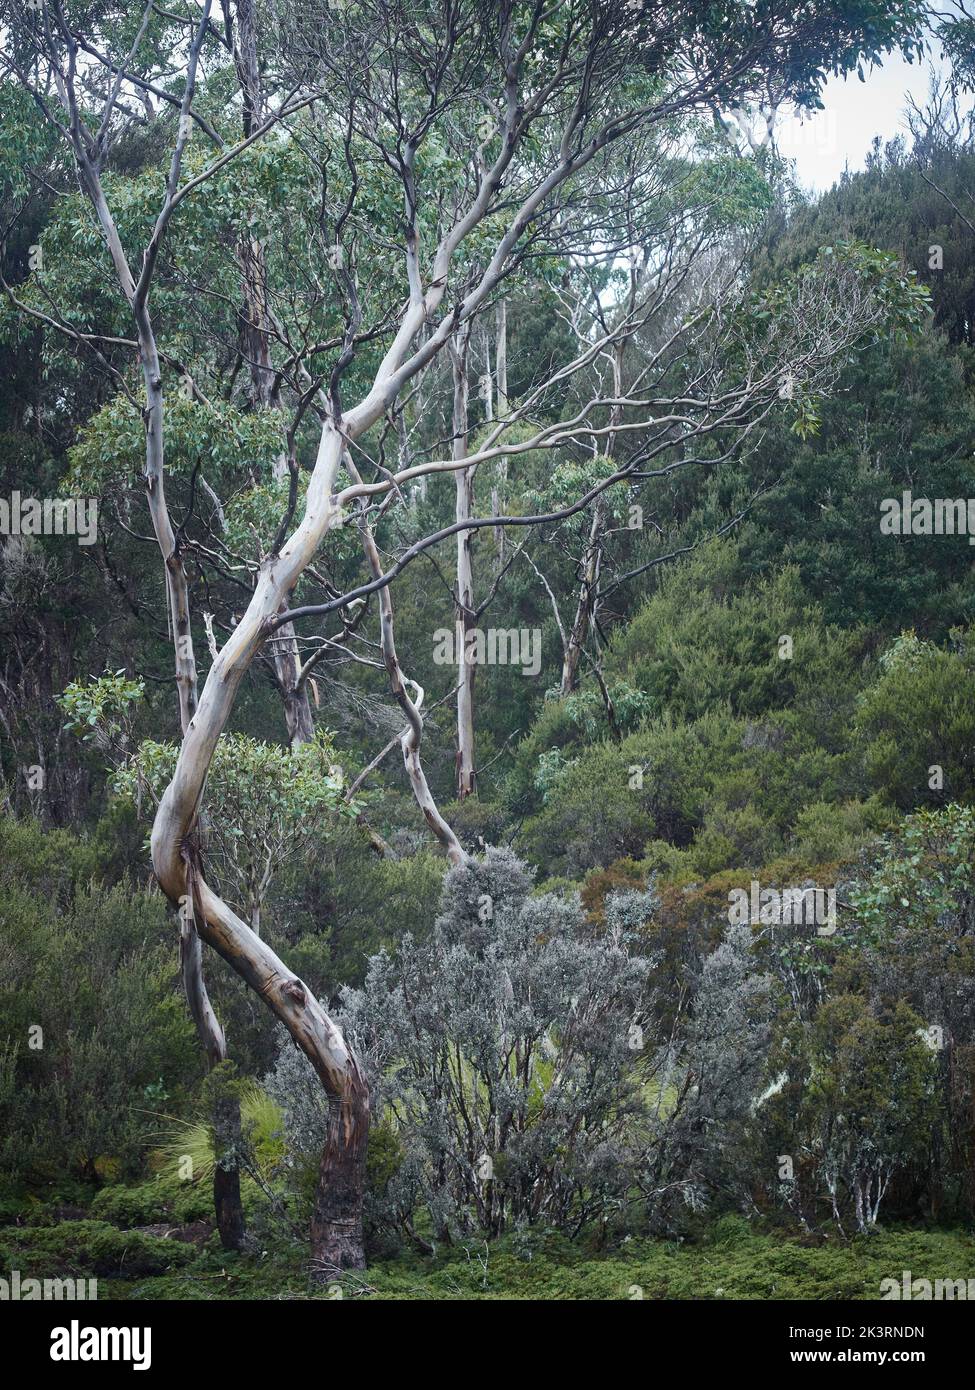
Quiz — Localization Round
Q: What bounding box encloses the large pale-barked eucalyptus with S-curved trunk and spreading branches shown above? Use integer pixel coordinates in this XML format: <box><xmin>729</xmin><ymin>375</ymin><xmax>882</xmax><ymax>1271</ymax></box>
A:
<box><xmin>0</xmin><ymin>0</ymin><xmax>921</xmax><ymax>1273</ymax></box>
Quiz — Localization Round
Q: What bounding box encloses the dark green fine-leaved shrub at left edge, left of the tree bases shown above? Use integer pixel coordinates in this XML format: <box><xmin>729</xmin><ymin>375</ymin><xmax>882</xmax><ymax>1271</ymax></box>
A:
<box><xmin>0</xmin><ymin>820</ymin><xmax>200</xmax><ymax>1183</ymax></box>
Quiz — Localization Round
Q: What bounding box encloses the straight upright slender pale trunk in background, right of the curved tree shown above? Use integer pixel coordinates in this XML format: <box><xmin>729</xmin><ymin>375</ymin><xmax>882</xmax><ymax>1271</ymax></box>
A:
<box><xmin>451</xmin><ymin>327</ymin><xmax>477</xmax><ymax>801</ymax></box>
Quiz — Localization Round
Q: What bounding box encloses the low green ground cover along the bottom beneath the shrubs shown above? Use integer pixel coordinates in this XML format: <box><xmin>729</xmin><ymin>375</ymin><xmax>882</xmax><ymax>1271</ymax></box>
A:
<box><xmin>0</xmin><ymin>1216</ymin><xmax>975</xmax><ymax>1301</ymax></box>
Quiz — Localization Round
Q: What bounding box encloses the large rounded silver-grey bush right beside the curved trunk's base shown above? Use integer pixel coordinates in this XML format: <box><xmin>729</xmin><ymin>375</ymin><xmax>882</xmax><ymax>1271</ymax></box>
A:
<box><xmin>268</xmin><ymin>849</ymin><xmax>650</xmax><ymax>1237</ymax></box>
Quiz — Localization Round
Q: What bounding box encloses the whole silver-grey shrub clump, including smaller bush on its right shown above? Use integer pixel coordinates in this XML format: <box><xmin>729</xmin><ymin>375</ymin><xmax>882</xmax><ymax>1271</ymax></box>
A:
<box><xmin>264</xmin><ymin>849</ymin><xmax>771</xmax><ymax>1238</ymax></box>
